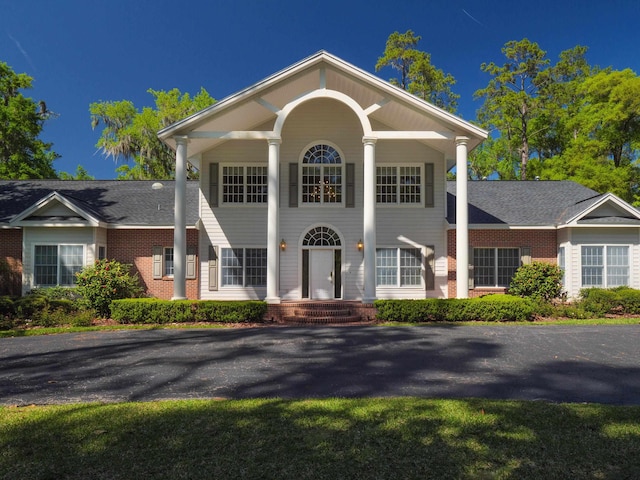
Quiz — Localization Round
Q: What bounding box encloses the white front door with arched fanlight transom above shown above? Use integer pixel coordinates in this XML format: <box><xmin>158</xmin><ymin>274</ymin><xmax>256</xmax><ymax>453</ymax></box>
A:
<box><xmin>302</xmin><ymin>226</ymin><xmax>342</xmax><ymax>300</ymax></box>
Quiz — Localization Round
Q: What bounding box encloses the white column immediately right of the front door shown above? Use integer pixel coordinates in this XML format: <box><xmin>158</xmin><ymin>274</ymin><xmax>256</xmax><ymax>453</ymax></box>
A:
<box><xmin>362</xmin><ymin>137</ymin><xmax>376</xmax><ymax>303</ymax></box>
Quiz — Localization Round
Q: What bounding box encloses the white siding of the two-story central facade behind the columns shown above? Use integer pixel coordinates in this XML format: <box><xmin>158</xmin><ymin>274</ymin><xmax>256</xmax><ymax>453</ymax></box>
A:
<box><xmin>200</xmin><ymin>99</ymin><xmax>447</xmax><ymax>300</ymax></box>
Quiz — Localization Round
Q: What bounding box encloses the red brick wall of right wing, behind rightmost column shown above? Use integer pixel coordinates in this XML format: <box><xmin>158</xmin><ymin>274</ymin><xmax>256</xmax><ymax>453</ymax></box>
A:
<box><xmin>447</xmin><ymin>230</ymin><xmax>558</xmax><ymax>298</ymax></box>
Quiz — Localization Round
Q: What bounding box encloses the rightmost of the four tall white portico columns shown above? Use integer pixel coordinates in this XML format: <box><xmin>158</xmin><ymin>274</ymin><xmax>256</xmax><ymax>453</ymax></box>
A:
<box><xmin>456</xmin><ymin>137</ymin><xmax>469</xmax><ymax>298</ymax></box>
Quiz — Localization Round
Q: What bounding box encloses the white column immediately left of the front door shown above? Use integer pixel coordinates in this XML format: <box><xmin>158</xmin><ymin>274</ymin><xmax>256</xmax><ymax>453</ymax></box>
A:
<box><xmin>265</xmin><ymin>139</ymin><xmax>281</xmax><ymax>303</ymax></box>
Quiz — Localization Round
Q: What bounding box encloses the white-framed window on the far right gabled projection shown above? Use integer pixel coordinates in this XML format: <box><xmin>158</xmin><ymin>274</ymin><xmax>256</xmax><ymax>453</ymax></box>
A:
<box><xmin>581</xmin><ymin>245</ymin><xmax>629</xmax><ymax>288</ymax></box>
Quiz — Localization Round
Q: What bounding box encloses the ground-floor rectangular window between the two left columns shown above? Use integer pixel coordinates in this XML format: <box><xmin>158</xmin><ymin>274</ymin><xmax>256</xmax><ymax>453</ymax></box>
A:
<box><xmin>221</xmin><ymin>248</ymin><xmax>267</xmax><ymax>287</ymax></box>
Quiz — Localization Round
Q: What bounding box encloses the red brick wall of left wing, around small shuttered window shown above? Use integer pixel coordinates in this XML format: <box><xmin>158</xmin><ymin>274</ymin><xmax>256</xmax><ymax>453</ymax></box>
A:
<box><xmin>107</xmin><ymin>229</ymin><xmax>200</xmax><ymax>300</ymax></box>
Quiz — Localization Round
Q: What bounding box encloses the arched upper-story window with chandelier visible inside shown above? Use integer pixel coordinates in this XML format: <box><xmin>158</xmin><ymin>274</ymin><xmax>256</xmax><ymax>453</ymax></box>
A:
<box><xmin>301</xmin><ymin>144</ymin><xmax>342</xmax><ymax>204</ymax></box>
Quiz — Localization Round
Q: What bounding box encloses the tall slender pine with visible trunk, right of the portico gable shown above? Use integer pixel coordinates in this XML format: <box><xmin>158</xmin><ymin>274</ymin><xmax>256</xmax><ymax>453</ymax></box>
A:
<box><xmin>474</xmin><ymin>38</ymin><xmax>550</xmax><ymax>180</ymax></box>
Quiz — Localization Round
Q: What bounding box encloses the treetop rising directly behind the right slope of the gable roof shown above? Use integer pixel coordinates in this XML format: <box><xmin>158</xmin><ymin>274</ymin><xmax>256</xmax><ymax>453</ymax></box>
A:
<box><xmin>376</xmin><ymin>30</ymin><xmax>460</xmax><ymax>112</ymax></box>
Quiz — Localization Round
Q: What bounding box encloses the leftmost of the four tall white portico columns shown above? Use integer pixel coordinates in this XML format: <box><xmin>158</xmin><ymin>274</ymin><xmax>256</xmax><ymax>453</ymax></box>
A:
<box><xmin>171</xmin><ymin>136</ymin><xmax>188</xmax><ymax>300</ymax></box>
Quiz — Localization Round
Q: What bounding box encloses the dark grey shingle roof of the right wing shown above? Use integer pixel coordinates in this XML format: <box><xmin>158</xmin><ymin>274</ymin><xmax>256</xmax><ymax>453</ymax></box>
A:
<box><xmin>447</xmin><ymin>180</ymin><xmax>601</xmax><ymax>226</ymax></box>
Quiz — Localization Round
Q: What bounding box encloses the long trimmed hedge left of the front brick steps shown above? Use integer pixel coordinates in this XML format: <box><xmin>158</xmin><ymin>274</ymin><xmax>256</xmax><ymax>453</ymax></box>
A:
<box><xmin>111</xmin><ymin>298</ymin><xmax>267</xmax><ymax>324</ymax></box>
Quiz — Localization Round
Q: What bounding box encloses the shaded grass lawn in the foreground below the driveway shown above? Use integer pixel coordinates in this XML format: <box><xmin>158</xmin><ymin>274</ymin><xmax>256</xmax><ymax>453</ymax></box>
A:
<box><xmin>0</xmin><ymin>398</ymin><xmax>640</xmax><ymax>480</ymax></box>
